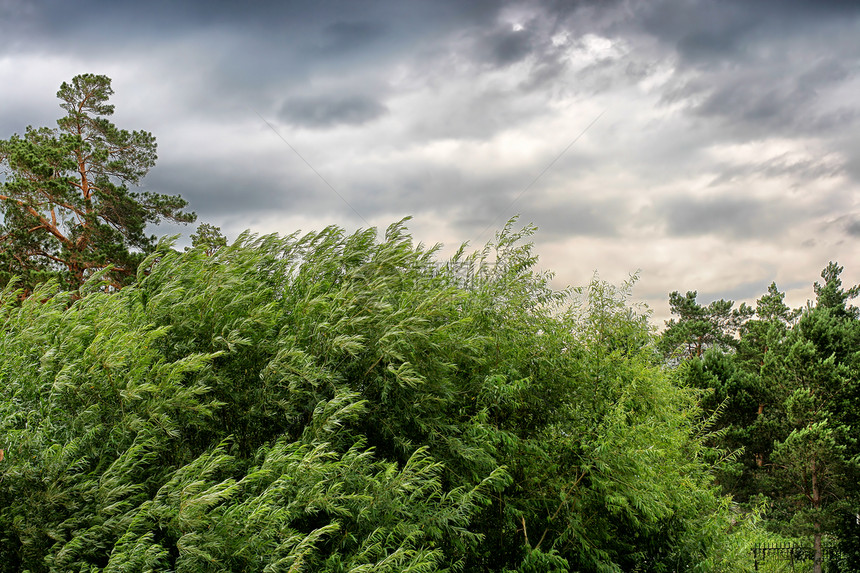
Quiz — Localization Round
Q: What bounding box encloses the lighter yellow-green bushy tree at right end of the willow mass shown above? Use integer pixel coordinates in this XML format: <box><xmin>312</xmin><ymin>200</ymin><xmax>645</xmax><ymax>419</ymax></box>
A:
<box><xmin>480</xmin><ymin>280</ymin><xmax>764</xmax><ymax>571</ymax></box>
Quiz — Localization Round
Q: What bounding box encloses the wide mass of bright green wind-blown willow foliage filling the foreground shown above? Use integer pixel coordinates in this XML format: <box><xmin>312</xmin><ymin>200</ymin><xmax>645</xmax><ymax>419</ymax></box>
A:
<box><xmin>0</xmin><ymin>224</ymin><xmax>758</xmax><ymax>573</ymax></box>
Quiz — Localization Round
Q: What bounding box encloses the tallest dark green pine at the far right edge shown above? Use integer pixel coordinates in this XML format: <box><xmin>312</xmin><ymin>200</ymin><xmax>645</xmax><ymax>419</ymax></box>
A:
<box><xmin>770</xmin><ymin>262</ymin><xmax>860</xmax><ymax>571</ymax></box>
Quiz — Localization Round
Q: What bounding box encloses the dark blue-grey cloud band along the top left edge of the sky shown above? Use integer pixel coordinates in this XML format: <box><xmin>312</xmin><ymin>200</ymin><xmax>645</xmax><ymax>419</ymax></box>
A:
<box><xmin>0</xmin><ymin>0</ymin><xmax>500</xmax><ymax>54</ymax></box>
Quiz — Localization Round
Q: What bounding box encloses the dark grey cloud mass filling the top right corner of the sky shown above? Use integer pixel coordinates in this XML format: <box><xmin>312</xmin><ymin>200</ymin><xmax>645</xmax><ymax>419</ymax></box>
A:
<box><xmin>576</xmin><ymin>0</ymin><xmax>860</xmax><ymax>147</ymax></box>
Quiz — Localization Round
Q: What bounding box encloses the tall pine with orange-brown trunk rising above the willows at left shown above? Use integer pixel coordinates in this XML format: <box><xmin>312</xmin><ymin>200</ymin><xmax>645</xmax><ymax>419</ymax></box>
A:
<box><xmin>0</xmin><ymin>74</ymin><xmax>196</xmax><ymax>288</ymax></box>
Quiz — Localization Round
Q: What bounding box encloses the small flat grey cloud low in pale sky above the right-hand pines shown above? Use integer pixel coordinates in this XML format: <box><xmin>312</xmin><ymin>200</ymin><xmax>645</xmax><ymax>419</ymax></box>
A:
<box><xmin>657</xmin><ymin>196</ymin><xmax>802</xmax><ymax>240</ymax></box>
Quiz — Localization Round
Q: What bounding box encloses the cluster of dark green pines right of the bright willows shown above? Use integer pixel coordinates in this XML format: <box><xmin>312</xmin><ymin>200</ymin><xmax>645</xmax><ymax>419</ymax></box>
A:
<box><xmin>667</xmin><ymin>263</ymin><xmax>860</xmax><ymax>568</ymax></box>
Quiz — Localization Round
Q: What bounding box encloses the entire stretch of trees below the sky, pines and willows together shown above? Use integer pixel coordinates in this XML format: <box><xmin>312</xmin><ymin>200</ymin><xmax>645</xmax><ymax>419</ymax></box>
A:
<box><xmin>0</xmin><ymin>75</ymin><xmax>860</xmax><ymax>573</ymax></box>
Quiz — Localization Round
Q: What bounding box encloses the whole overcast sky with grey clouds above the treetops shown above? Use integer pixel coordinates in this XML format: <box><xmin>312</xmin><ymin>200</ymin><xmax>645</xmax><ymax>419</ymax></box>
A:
<box><xmin>0</xmin><ymin>0</ymin><xmax>860</xmax><ymax>323</ymax></box>
